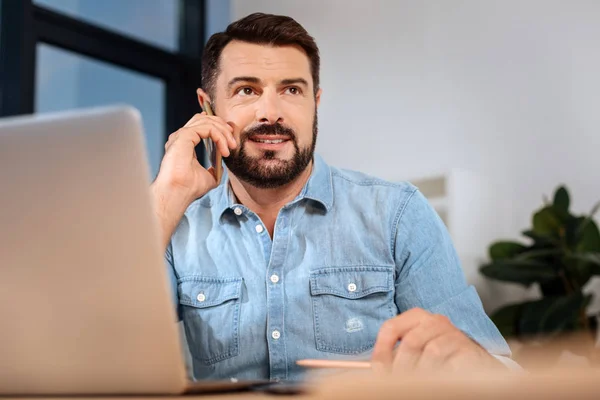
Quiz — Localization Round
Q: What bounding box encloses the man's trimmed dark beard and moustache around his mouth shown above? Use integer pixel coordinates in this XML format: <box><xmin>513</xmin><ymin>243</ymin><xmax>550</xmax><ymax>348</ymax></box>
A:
<box><xmin>224</xmin><ymin>110</ymin><xmax>318</xmax><ymax>189</ymax></box>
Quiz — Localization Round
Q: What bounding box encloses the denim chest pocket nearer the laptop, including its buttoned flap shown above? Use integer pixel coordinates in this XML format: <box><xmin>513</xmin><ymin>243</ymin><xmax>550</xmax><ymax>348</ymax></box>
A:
<box><xmin>178</xmin><ymin>276</ymin><xmax>242</xmax><ymax>365</ymax></box>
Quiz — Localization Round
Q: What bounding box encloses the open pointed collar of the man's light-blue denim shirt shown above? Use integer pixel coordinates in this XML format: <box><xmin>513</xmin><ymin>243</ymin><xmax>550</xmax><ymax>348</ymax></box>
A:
<box><xmin>200</xmin><ymin>154</ymin><xmax>333</xmax><ymax>217</ymax></box>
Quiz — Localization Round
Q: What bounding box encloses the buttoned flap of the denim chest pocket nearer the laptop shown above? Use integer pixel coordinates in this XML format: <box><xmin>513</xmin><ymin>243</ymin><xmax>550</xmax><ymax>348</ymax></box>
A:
<box><xmin>178</xmin><ymin>276</ymin><xmax>242</xmax><ymax>308</ymax></box>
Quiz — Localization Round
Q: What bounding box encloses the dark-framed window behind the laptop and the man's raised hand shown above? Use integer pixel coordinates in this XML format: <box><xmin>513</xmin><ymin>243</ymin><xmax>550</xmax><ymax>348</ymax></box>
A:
<box><xmin>0</xmin><ymin>0</ymin><xmax>206</xmax><ymax>168</ymax></box>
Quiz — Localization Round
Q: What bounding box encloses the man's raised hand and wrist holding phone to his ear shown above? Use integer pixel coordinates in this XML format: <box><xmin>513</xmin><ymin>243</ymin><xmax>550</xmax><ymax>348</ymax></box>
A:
<box><xmin>151</xmin><ymin>112</ymin><xmax>237</xmax><ymax>249</ymax></box>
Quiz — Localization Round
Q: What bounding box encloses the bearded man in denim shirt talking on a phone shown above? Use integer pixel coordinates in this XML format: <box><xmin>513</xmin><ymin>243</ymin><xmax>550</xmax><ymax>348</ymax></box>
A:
<box><xmin>152</xmin><ymin>14</ymin><xmax>510</xmax><ymax>380</ymax></box>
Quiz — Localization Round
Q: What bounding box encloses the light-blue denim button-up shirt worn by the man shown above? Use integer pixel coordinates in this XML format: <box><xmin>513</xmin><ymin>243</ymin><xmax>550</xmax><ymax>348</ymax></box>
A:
<box><xmin>166</xmin><ymin>156</ymin><xmax>510</xmax><ymax>380</ymax></box>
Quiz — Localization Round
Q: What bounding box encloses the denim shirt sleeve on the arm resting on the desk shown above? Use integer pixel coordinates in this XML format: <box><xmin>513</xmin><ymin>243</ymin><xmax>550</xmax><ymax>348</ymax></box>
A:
<box><xmin>394</xmin><ymin>190</ymin><xmax>511</xmax><ymax>357</ymax></box>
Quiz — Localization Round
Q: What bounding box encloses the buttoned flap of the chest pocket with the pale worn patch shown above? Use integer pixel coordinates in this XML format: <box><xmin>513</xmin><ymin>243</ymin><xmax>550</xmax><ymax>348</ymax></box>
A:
<box><xmin>310</xmin><ymin>267</ymin><xmax>394</xmax><ymax>299</ymax></box>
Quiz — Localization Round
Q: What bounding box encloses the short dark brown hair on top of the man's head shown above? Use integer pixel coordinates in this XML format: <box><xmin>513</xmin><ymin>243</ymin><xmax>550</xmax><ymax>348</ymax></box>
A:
<box><xmin>202</xmin><ymin>13</ymin><xmax>321</xmax><ymax>101</ymax></box>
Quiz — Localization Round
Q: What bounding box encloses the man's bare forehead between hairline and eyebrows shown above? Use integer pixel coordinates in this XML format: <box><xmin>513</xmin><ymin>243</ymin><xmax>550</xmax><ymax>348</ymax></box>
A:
<box><xmin>219</xmin><ymin>41</ymin><xmax>312</xmax><ymax>82</ymax></box>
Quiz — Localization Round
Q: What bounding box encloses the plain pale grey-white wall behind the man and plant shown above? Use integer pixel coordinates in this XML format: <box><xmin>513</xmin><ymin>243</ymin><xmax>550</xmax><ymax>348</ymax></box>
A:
<box><xmin>231</xmin><ymin>0</ymin><xmax>600</xmax><ymax>310</ymax></box>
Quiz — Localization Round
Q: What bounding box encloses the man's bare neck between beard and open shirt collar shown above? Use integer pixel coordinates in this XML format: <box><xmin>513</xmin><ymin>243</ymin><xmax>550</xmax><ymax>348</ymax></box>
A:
<box><xmin>229</xmin><ymin>162</ymin><xmax>313</xmax><ymax>237</ymax></box>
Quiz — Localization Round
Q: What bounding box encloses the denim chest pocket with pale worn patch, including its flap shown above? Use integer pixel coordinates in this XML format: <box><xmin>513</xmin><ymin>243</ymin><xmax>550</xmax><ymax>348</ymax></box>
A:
<box><xmin>310</xmin><ymin>267</ymin><xmax>397</xmax><ymax>354</ymax></box>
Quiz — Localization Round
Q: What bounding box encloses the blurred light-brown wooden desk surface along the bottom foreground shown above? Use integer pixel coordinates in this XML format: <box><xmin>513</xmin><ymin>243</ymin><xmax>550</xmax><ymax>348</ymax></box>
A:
<box><xmin>8</xmin><ymin>368</ymin><xmax>600</xmax><ymax>400</ymax></box>
